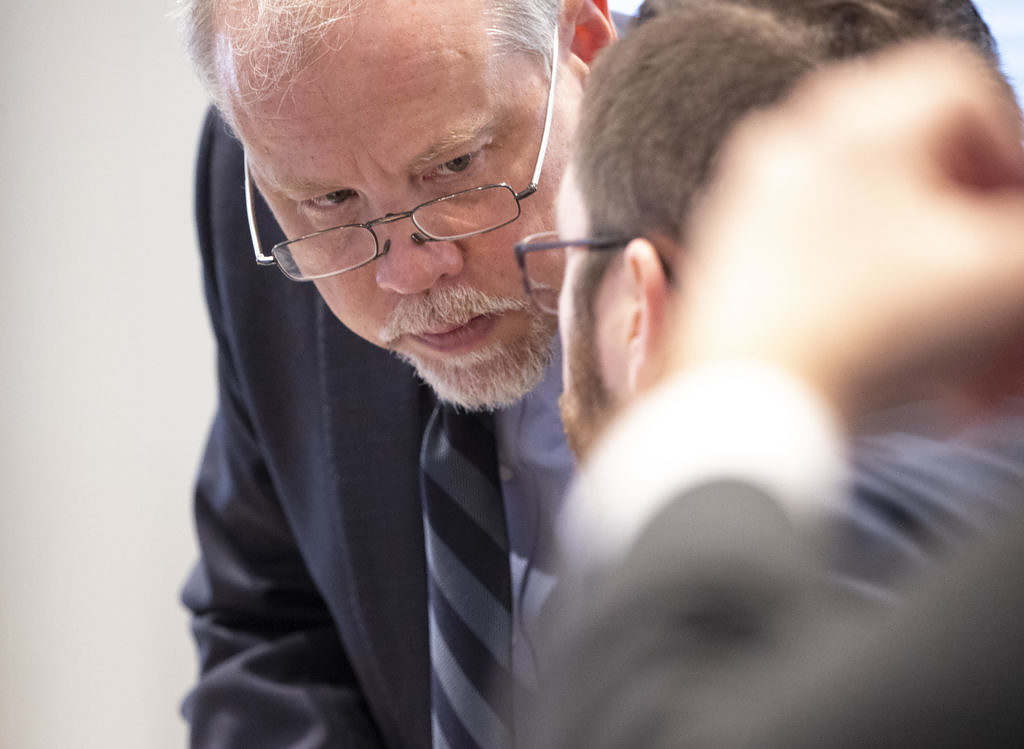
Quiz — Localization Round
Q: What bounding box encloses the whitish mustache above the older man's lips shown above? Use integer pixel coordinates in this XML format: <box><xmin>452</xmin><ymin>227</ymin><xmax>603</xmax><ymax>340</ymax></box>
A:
<box><xmin>380</xmin><ymin>286</ymin><xmax>530</xmax><ymax>345</ymax></box>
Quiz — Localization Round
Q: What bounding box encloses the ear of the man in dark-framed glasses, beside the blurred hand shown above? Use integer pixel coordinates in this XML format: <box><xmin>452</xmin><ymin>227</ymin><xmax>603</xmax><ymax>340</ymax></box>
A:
<box><xmin>623</xmin><ymin>238</ymin><xmax>669</xmax><ymax>393</ymax></box>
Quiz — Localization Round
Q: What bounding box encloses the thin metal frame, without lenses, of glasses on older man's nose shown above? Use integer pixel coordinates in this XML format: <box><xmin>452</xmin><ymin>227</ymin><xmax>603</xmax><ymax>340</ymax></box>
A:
<box><xmin>242</xmin><ymin>26</ymin><xmax>558</xmax><ymax>281</ymax></box>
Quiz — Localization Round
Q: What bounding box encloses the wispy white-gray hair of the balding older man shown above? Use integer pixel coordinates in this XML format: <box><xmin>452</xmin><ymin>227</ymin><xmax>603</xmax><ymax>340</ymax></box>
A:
<box><xmin>176</xmin><ymin>0</ymin><xmax>559</xmax><ymax>114</ymax></box>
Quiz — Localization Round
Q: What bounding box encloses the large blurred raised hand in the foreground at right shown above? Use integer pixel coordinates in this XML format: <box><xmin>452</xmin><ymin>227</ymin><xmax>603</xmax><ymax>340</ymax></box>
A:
<box><xmin>667</xmin><ymin>42</ymin><xmax>1024</xmax><ymax>423</ymax></box>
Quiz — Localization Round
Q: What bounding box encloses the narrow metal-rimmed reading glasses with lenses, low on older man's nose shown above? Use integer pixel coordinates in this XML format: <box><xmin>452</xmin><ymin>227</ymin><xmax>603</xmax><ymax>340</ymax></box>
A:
<box><xmin>244</xmin><ymin>28</ymin><xmax>558</xmax><ymax>281</ymax></box>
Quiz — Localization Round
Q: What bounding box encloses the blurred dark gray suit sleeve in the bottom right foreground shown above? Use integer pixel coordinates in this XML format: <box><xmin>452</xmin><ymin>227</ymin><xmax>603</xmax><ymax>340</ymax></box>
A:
<box><xmin>537</xmin><ymin>481</ymin><xmax>1024</xmax><ymax>749</ymax></box>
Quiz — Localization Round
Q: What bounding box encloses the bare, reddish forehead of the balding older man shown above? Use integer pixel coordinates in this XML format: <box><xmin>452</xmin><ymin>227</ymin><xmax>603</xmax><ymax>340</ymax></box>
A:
<box><xmin>220</xmin><ymin>0</ymin><xmax>532</xmax><ymax>186</ymax></box>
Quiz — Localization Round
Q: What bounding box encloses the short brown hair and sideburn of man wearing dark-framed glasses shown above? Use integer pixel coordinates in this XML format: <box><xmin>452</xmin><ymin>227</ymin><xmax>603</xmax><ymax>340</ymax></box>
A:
<box><xmin>572</xmin><ymin>0</ymin><xmax>820</xmax><ymax>311</ymax></box>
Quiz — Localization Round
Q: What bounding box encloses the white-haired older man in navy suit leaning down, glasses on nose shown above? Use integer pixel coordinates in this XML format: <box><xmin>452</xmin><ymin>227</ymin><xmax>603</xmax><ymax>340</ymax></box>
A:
<box><xmin>174</xmin><ymin>0</ymin><xmax>614</xmax><ymax>749</ymax></box>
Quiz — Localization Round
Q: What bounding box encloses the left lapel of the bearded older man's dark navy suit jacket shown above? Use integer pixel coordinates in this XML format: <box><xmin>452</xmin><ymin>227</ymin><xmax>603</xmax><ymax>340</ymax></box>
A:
<box><xmin>317</xmin><ymin>303</ymin><xmax>432</xmax><ymax>746</ymax></box>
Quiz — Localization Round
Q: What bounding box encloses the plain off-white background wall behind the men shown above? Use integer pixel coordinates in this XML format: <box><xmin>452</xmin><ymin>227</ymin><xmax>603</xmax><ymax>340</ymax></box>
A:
<box><xmin>0</xmin><ymin>0</ymin><xmax>1024</xmax><ymax>749</ymax></box>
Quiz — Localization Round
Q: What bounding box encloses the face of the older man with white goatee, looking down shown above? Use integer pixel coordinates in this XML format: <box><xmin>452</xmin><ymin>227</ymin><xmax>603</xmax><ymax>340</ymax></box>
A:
<box><xmin>221</xmin><ymin>0</ymin><xmax>582</xmax><ymax>407</ymax></box>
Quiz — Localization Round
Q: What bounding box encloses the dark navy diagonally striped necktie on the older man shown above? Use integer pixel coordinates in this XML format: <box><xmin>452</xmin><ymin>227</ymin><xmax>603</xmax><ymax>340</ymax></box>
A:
<box><xmin>420</xmin><ymin>405</ymin><xmax>513</xmax><ymax>749</ymax></box>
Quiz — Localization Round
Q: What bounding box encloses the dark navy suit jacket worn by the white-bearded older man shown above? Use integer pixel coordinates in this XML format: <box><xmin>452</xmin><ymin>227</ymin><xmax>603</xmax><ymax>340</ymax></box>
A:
<box><xmin>182</xmin><ymin>108</ymin><xmax>433</xmax><ymax>748</ymax></box>
